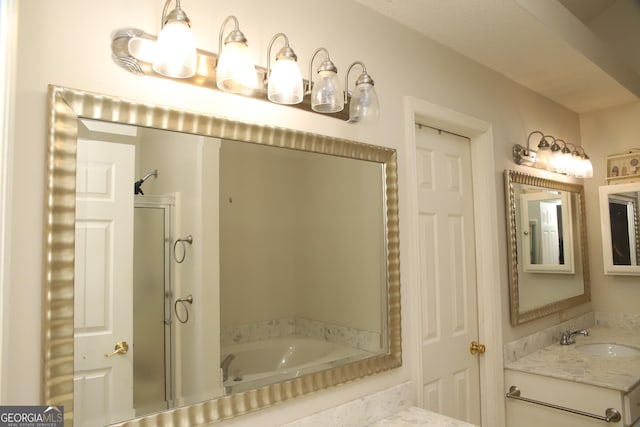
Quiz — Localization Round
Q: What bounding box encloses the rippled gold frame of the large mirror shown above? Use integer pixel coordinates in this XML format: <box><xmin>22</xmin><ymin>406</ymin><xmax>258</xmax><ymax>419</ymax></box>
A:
<box><xmin>42</xmin><ymin>85</ymin><xmax>402</xmax><ymax>427</ymax></box>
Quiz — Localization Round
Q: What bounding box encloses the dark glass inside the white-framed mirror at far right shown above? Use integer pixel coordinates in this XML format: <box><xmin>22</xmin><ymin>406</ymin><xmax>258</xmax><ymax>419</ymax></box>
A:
<box><xmin>609</xmin><ymin>194</ymin><xmax>638</xmax><ymax>265</ymax></box>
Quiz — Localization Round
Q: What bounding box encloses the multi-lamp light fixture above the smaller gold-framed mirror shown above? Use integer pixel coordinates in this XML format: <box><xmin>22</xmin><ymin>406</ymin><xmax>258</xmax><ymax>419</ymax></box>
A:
<box><xmin>512</xmin><ymin>130</ymin><xmax>593</xmax><ymax>178</ymax></box>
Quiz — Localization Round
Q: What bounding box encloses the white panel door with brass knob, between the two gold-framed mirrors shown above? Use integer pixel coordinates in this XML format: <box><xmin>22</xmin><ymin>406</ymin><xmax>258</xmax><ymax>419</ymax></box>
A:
<box><xmin>416</xmin><ymin>126</ymin><xmax>480</xmax><ymax>425</ymax></box>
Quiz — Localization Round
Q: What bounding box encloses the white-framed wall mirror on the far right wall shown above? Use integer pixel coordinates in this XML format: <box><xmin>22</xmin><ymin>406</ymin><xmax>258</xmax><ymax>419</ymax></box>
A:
<box><xmin>599</xmin><ymin>183</ymin><xmax>640</xmax><ymax>275</ymax></box>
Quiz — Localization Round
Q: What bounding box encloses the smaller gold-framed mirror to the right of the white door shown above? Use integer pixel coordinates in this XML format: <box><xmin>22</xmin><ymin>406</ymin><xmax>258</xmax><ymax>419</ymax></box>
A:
<box><xmin>505</xmin><ymin>170</ymin><xmax>591</xmax><ymax>326</ymax></box>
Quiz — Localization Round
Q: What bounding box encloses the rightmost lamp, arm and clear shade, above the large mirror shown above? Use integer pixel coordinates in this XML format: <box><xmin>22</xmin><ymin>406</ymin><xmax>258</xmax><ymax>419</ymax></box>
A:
<box><xmin>344</xmin><ymin>61</ymin><xmax>380</xmax><ymax>123</ymax></box>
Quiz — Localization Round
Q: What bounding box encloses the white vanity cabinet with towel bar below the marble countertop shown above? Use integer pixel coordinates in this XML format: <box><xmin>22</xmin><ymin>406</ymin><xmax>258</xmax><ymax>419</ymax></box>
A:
<box><xmin>505</xmin><ymin>366</ymin><xmax>640</xmax><ymax>427</ymax></box>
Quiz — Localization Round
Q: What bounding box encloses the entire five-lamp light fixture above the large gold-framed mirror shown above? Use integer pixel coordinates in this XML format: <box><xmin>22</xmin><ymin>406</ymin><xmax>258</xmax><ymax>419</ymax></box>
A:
<box><xmin>111</xmin><ymin>0</ymin><xmax>380</xmax><ymax>122</ymax></box>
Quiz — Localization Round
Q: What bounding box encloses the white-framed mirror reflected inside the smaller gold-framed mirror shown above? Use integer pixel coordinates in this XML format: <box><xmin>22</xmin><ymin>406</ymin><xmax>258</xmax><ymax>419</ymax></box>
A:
<box><xmin>520</xmin><ymin>191</ymin><xmax>573</xmax><ymax>273</ymax></box>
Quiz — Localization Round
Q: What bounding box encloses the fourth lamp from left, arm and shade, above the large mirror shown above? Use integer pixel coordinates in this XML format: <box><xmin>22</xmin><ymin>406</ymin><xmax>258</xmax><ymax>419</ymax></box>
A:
<box><xmin>307</xmin><ymin>47</ymin><xmax>344</xmax><ymax>113</ymax></box>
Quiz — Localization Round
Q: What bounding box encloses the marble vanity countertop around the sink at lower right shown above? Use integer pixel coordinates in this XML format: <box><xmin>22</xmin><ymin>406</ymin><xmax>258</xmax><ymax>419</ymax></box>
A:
<box><xmin>505</xmin><ymin>327</ymin><xmax>640</xmax><ymax>393</ymax></box>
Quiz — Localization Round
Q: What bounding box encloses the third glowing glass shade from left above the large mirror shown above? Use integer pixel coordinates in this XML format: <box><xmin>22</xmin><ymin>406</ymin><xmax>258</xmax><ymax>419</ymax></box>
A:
<box><xmin>267</xmin><ymin>58</ymin><xmax>304</xmax><ymax>105</ymax></box>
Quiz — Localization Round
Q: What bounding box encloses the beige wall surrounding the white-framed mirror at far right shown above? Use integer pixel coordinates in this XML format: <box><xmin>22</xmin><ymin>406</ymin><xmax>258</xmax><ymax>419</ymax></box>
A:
<box><xmin>580</xmin><ymin>102</ymin><xmax>640</xmax><ymax>314</ymax></box>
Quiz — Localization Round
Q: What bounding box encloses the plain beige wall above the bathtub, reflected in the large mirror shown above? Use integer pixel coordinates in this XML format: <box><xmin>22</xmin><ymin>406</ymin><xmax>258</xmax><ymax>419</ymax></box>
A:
<box><xmin>220</xmin><ymin>141</ymin><xmax>386</xmax><ymax>332</ymax></box>
